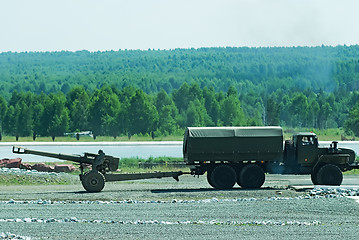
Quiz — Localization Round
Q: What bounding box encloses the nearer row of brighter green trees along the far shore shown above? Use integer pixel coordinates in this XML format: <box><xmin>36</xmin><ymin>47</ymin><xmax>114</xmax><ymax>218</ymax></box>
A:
<box><xmin>0</xmin><ymin>83</ymin><xmax>359</xmax><ymax>137</ymax></box>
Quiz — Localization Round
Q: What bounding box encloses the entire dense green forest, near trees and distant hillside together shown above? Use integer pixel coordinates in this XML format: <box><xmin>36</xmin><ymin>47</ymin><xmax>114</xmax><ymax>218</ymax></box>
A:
<box><xmin>0</xmin><ymin>45</ymin><xmax>359</xmax><ymax>136</ymax></box>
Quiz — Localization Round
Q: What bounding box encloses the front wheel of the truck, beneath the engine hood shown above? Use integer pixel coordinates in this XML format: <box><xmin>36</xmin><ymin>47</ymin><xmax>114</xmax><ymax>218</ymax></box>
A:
<box><xmin>317</xmin><ymin>164</ymin><xmax>343</xmax><ymax>186</ymax></box>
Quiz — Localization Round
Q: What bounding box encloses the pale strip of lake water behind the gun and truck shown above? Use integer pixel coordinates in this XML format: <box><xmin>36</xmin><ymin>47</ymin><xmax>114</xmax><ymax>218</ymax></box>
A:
<box><xmin>0</xmin><ymin>141</ymin><xmax>359</xmax><ymax>162</ymax></box>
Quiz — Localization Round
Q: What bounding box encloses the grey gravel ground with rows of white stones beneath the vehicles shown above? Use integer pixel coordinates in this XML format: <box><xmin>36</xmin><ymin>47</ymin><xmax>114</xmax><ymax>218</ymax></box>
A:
<box><xmin>0</xmin><ymin>175</ymin><xmax>359</xmax><ymax>239</ymax></box>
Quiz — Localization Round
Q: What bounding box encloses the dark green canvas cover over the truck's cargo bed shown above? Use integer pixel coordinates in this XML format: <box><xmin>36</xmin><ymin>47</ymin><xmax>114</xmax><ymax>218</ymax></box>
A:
<box><xmin>183</xmin><ymin>127</ymin><xmax>283</xmax><ymax>164</ymax></box>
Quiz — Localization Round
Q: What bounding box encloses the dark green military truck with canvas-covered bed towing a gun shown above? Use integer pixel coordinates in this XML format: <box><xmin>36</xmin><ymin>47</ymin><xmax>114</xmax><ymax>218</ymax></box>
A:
<box><xmin>183</xmin><ymin>127</ymin><xmax>359</xmax><ymax>189</ymax></box>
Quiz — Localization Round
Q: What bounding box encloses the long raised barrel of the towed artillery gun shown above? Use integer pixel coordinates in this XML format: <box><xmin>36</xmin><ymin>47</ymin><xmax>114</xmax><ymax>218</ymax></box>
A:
<box><xmin>12</xmin><ymin>146</ymin><xmax>95</xmax><ymax>164</ymax></box>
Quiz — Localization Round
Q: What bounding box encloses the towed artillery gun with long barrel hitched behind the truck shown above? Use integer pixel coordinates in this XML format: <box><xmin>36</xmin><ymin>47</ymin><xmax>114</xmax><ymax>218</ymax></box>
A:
<box><xmin>12</xmin><ymin>146</ymin><xmax>183</xmax><ymax>192</ymax></box>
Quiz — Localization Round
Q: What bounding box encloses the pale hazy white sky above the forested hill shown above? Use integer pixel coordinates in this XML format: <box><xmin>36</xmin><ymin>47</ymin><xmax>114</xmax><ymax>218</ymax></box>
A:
<box><xmin>0</xmin><ymin>0</ymin><xmax>359</xmax><ymax>52</ymax></box>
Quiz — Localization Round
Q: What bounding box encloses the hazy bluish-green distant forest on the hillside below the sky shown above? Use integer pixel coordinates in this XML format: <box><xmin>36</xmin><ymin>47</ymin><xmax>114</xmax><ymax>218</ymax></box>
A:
<box><xmin>0</xmin><ymin>45</ymin><xmax>359</xmax><ymax>100</ymax></box>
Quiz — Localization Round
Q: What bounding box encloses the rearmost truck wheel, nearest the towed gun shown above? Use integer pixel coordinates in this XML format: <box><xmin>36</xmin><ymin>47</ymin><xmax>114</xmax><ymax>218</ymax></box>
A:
<box><xmin>209</xmin><ymin>164</ymin><xmax>237</xmax><ymax>189</ymax></box>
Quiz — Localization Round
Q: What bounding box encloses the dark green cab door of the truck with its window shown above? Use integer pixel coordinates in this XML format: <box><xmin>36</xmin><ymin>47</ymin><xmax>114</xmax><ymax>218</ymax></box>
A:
<box><xmin>297</xmin><ymin>135</ymin><xmax>318</xmax><ymax>165</ymax></box>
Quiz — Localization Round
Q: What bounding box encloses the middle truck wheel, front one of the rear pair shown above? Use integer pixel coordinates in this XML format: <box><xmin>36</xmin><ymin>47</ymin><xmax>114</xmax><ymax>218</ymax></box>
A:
<box><xmin>239</xmin><ymin>164</ymin><xmax>265</xmax><ymax>189</ymax></box>
